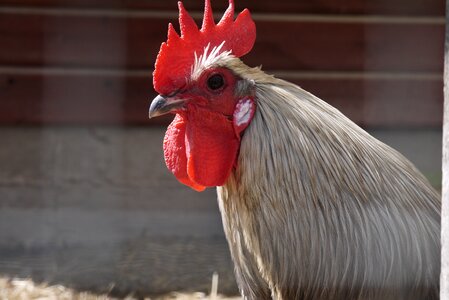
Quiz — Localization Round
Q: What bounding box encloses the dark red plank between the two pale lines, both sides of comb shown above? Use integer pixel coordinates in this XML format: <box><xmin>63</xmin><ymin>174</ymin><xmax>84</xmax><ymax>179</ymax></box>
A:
<box><xmin>0</xmin><ymin>13</ymin><xmax>444</xmax><ymax>72</ymax></box>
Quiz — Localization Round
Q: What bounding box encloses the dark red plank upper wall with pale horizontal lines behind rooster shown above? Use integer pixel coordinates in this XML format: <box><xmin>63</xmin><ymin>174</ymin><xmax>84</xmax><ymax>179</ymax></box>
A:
<box><xmin>0</xmin><ymin>0</ymin><xmax>444</xmax><ymax>127</ymax></box>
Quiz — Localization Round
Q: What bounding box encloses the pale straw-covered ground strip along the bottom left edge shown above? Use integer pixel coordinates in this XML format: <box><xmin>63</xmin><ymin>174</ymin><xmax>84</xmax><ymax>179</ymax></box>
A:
<box><xmin>0</xmin><ymin>278</ymin><xmax>241</xmax><ymax>300</ymax></box>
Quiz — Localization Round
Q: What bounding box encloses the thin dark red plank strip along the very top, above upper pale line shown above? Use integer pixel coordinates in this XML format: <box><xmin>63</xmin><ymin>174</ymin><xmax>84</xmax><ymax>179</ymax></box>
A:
<box><xmin>0</xmin><ymin>0</ymin><xmax>445</xmax><ymax>16</ymax></box>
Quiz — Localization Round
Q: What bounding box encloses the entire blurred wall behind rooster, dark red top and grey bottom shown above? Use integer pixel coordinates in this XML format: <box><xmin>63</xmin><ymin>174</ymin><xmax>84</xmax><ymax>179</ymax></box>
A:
<box><xmin>0</xmin><ymin>0</ymin><xmax>445</xmax><ymax>295</ymax></box>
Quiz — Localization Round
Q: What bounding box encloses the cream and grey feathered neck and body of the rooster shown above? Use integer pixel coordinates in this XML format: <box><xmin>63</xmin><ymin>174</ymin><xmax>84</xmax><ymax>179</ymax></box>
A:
<box><xmin>215</xmin><ymin>56</ymin><xmax>440</xmax><ymax>300</ymax></box>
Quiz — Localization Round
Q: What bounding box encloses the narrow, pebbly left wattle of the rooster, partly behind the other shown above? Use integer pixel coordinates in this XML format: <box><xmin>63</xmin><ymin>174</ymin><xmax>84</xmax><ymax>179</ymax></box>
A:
<box><xmin>164</xmin><ymin>114</ymin><xmax>206</xmax><ymax>192</ymax></box>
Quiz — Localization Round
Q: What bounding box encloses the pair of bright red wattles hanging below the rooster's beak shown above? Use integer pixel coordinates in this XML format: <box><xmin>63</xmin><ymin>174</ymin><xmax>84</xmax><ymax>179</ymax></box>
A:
<box><xmin>164</xmin><ymin>107</ymin><xmax>239</xmax><ymax>191</ymax></box>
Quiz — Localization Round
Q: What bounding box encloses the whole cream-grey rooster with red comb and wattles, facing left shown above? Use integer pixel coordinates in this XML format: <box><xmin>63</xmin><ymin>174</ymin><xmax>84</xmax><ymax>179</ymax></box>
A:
<box><xmin>149</xmin><ymin>0</ymin><xmax>440</xmax><ymax>300</ymax></box>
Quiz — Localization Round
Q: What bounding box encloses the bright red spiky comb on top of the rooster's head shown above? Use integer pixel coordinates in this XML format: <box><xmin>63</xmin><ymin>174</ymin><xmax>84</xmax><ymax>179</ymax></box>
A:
<box><xmin>153</xmin><ymin>0</ymin><xmax>256</xmax><ymax>94</ymax></box>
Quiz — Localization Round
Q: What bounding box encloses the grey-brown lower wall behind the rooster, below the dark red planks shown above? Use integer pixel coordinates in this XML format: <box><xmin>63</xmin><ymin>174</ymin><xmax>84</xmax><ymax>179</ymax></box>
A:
<box><xmin>0</xmin><ymin>127</ymin><xmax>441</xmax><ymax>294</ymax></box>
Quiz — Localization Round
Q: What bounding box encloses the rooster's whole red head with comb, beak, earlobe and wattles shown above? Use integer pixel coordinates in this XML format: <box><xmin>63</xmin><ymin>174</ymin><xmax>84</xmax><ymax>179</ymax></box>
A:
<box><xmin>149</xmin><ymin>0</ymin><xmax>256</xmax><ymax>191</ymax></box>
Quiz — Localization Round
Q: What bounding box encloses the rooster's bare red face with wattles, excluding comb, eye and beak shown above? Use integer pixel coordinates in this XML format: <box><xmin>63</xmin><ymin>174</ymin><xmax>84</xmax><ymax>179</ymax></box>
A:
<box><xmin>164</xmin><ymin>69</ymin><xmax>255</xmax><ymax>191</ymax></box>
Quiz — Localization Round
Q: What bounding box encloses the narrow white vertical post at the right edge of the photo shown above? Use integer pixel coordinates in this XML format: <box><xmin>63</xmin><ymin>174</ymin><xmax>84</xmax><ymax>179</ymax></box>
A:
<box><xmin>440</xmin><ymin>0</ymin><xmax>449</xmax><ymax>300</ymax></box>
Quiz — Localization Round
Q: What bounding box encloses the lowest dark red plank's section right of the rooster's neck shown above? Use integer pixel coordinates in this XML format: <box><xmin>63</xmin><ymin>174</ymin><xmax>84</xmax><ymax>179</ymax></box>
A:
<box><xmin>294</xmin><ymin>79</ymin><xmax>443</xmax><ymax>128</ymax></box>
